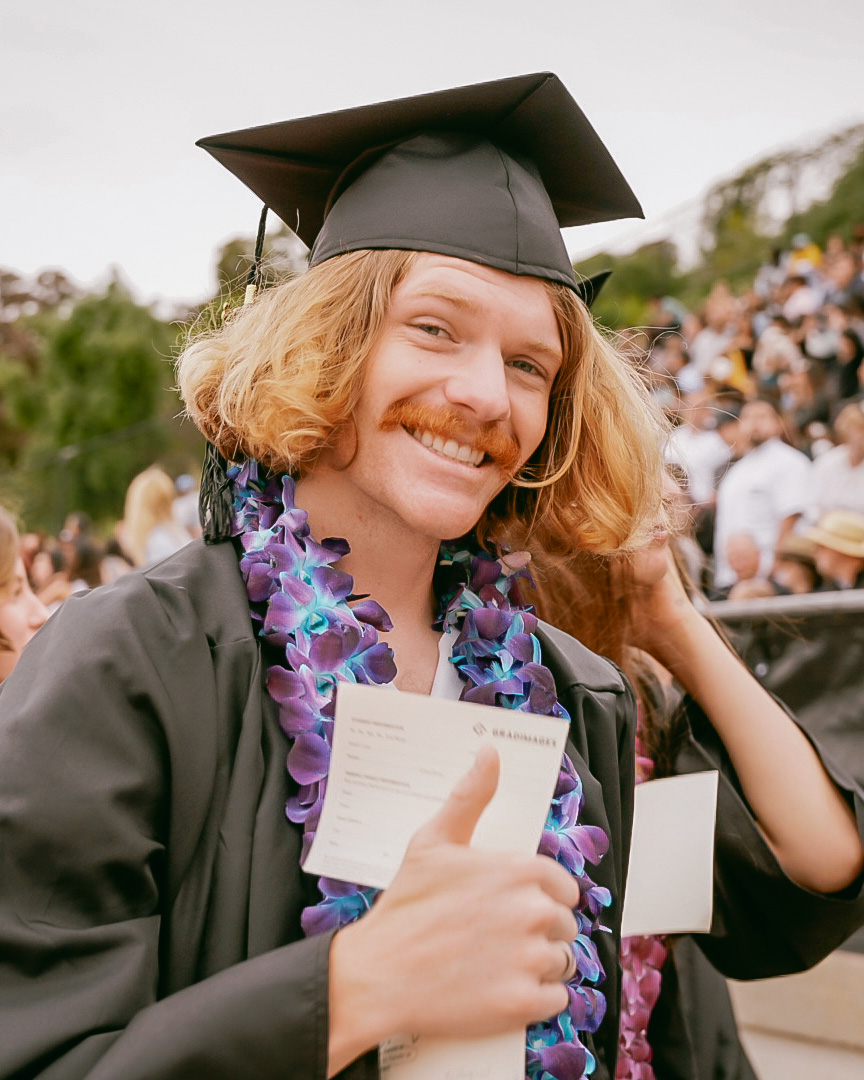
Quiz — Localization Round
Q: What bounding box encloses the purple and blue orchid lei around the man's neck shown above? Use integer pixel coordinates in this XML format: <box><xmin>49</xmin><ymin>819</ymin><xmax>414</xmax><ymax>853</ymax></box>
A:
<box><xmin>228</xmin><ymin>461</ymin><xmax>611</xmax><ymax>1080</ymax></box>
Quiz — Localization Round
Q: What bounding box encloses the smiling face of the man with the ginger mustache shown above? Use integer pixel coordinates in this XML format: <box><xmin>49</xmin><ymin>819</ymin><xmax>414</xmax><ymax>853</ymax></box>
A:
<box><xmin>320</xmin><ymin>253</ymin><xmax>562</xmax><ymax>540</ymax></box>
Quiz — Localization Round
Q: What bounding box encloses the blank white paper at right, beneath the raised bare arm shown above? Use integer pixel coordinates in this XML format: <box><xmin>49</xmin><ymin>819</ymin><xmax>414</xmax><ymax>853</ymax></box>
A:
<box><xmin>621</xmin><ymin>770</ymin><xmax>719</xmax><ymax>936</ymax></box>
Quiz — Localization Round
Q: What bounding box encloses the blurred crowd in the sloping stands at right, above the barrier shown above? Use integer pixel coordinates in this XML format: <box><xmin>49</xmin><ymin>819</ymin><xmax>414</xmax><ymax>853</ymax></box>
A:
<box><xmin>643</xmin><ymin>226</ymin><xmax>864</xmax><ymax>599</ymax></box>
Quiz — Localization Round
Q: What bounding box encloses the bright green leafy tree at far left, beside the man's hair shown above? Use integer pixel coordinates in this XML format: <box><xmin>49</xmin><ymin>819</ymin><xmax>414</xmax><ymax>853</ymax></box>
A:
<box><xmin>0</xmin><ymin>281</ymin><xmax>192</xmax><ymax>530</ymax></box>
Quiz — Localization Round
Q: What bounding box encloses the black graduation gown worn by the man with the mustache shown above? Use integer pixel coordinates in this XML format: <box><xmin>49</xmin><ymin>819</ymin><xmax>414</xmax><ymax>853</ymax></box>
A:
<box><xmin>0</xmin><ymin>542</ymin><xmax>634</xmax><ymax>1080</ymax></box>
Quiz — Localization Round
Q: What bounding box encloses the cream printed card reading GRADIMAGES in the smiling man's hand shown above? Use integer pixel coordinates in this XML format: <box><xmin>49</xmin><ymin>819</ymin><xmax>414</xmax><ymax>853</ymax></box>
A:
<box><xmin>303</xmin><ymin>683</ymin><xmax>568</xmax><ymax>1080</ymax></box>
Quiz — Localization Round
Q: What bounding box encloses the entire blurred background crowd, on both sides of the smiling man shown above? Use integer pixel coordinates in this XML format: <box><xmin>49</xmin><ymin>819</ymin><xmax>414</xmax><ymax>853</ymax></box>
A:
<box><xmin>0</xmin><ymin>226</ymin><xmax>864</xmax><ymax>680</ymax></box>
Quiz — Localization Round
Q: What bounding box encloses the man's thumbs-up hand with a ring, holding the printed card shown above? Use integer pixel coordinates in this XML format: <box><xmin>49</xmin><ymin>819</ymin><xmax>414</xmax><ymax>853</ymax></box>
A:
<box><xmin>329</xmin><ymin>747</ymin><xmax>579</xmax><ymax>1070</ymax></box>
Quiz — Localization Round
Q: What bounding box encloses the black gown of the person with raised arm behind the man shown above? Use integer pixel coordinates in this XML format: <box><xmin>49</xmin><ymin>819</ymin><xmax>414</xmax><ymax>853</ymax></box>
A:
<box><xmin>648</xmin><ymin>697</ymin><xmax>864</xmax><ymax>1080</ymax></box>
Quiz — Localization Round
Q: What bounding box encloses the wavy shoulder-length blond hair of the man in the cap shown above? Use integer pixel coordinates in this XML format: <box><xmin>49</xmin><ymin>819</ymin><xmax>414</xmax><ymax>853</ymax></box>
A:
<box><xmin>177</xmin><ymin>251</ymin><xmax>664</xmax><ymax>556</ymax></box>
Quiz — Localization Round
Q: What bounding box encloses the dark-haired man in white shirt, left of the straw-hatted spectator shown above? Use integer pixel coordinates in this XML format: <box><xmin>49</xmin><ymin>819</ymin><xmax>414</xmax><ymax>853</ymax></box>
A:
<box><xmin>714</xmin><ymin>399</ymin><xmax>812</xmax><ymax>589</ymax></box>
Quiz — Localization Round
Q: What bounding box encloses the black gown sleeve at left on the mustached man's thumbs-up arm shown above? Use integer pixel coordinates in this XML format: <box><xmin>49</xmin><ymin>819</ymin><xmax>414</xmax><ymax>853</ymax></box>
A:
<box><xmin>0</xmin><ymin>575</ymin><xmax>374</xmax><ymax>1080</ymax></box>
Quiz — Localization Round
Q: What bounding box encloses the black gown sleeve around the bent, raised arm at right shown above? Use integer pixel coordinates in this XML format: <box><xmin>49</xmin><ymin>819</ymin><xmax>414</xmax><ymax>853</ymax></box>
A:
<box><xmin>675</xmin><ymin>698</ymin><xmax>864</xmax><ymax>978</ymax></box>
